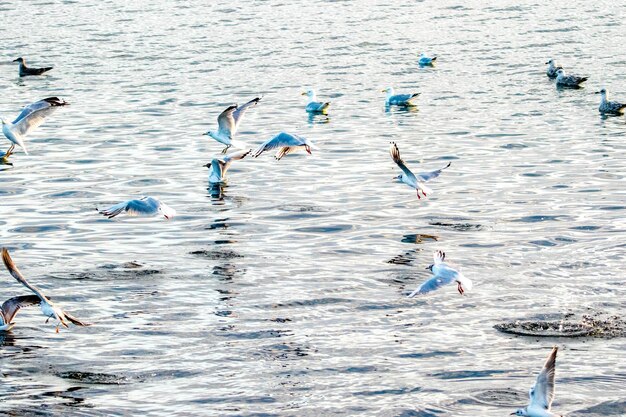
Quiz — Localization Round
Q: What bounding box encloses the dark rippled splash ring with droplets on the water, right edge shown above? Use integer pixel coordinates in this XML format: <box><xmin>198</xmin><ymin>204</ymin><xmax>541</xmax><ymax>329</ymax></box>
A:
<box><xmin>493</xmin><ymin>313</ymin><xmax>626</xmax><ymax>339</ymax></box>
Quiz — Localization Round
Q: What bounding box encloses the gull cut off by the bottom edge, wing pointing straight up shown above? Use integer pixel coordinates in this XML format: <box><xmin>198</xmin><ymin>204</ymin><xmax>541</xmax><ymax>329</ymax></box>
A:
<box><xmin>511</xmin><ymin>346</ymin><xmax>563</xmax><ymax>417</ymax></box>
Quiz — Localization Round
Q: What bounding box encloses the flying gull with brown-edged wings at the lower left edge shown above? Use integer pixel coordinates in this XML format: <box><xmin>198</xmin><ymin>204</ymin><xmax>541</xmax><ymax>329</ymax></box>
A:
<box><xmin>2</xmin><ymin>248</ymin><xmax>90</xmax><ymax>333</ymax></box>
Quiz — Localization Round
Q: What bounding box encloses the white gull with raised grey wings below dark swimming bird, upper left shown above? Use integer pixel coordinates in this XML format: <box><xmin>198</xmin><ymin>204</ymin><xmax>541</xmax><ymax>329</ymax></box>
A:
<box><xmin>2</xmin><ymin>97</ymin><xmax>69</xmax><ymax>155</ymax></box>
